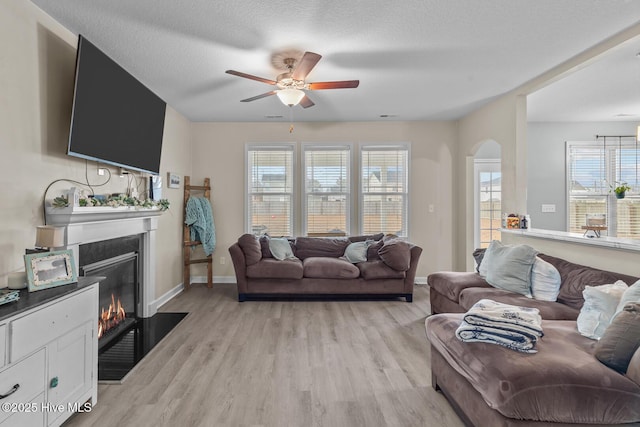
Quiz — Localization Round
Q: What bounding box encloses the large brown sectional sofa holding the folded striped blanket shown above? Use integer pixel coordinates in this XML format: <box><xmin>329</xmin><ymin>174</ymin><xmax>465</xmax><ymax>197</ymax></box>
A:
<box><xmin>425</xmin><ymin>254</ymin><xmax>640</xmax><ymax>427</ymax></box>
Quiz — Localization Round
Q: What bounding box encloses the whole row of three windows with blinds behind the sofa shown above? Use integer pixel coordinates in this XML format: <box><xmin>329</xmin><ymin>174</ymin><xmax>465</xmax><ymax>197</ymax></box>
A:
<box><xmin>245</xmin><ymin>143</ymin><xmax>410</xmax><ymax>237</ymax></box>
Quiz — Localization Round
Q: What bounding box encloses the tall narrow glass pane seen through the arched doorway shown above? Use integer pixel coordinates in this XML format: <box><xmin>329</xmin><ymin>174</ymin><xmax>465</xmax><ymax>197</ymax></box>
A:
<box><xmin>474</xmin><ymin>160</ymin><xmax>502</xmax><ymax>248</ymax></box>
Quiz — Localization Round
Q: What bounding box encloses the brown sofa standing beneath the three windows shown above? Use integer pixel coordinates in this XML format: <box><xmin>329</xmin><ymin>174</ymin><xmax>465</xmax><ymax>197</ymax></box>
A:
<box><xmin>229</xmin><ymin>234</ymin><xmax>422</xmax><ymax>302</ymax></box>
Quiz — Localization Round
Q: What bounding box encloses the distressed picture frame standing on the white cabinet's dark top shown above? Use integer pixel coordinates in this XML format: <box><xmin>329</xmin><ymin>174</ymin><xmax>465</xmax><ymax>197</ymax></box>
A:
<box><xmin>24</xmin><ymin>250</ymin><xmax>78</xmax><ymax>292</ymax></box>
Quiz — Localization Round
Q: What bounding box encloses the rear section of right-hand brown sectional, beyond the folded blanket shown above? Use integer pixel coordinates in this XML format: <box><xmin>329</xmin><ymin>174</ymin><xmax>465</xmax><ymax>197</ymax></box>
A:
<box><xmin>427</xmin><ymin>254</ymin><xmax>638</xmax><ymax>320</ymax></box>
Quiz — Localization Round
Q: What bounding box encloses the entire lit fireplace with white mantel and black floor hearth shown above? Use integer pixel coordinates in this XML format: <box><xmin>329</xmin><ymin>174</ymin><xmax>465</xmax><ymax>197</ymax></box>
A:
<box><xmin>46</xmin><ymin>206</ymin><xmax>186</xmax><ymax>383</ymax></box>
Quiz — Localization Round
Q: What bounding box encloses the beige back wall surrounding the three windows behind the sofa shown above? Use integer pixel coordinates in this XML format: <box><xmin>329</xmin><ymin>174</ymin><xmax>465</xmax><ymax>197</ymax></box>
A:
<box><xmin>193</xmin><ymin>122</ymin><xmax>457</xmax><ymax>278</ymax></box>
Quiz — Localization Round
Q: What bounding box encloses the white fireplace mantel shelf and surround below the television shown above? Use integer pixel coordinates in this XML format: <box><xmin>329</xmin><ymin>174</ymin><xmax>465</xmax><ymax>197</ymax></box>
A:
<box><xmin>45</xmin><ymin>206</ymin><xmax>163</xmax><ymax>317</ymax></box>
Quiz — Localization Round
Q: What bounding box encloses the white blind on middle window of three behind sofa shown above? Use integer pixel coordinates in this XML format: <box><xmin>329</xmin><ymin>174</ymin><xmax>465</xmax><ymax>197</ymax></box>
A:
<box><xmin>304</xmin><ymin>145</ymin><xmax>351</xmax><ymax>236</ymax></box>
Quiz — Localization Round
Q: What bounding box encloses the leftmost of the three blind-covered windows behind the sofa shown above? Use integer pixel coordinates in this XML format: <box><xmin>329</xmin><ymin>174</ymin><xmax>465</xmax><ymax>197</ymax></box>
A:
<box><xmin>247</xmin><ymin>144</ymin><xmax>294</xmax><ymax>236</ymax></box>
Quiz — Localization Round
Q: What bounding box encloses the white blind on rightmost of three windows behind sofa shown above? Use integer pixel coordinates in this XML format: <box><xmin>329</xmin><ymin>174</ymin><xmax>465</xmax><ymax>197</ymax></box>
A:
<box><xmin>360</xmin><ymin>145</ymin><xmax>409</xmax><ymax>236</ymax></box>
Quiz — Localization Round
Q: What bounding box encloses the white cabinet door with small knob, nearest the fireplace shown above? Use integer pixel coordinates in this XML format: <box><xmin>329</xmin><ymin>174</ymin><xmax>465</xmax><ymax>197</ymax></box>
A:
<box><xmin>47</xmin><ymin>321</ymin><xmax>95</xmax><ymax>425</ymax></box>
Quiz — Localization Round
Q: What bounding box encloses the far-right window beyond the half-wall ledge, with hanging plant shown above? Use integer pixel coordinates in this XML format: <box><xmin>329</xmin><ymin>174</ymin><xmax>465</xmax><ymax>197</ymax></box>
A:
<box><xmin>567</xmin><ymin>137</ymin><xmax>640</xmax><ymax>239</ymax></box>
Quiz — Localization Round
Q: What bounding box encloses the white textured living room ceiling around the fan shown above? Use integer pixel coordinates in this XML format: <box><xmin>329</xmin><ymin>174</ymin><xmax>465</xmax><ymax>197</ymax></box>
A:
<box><xmin>32</xmin><ymin>0</ymin><xmax>640</xmax><ymax>121</ymax></box>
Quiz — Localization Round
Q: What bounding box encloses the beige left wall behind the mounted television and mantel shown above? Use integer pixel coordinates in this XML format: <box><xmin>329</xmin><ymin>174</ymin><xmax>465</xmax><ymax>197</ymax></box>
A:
<box><xmin>0</xmin><ymin>0</ymin><xmax>191</xmax><ymax>297</ymax></box>
